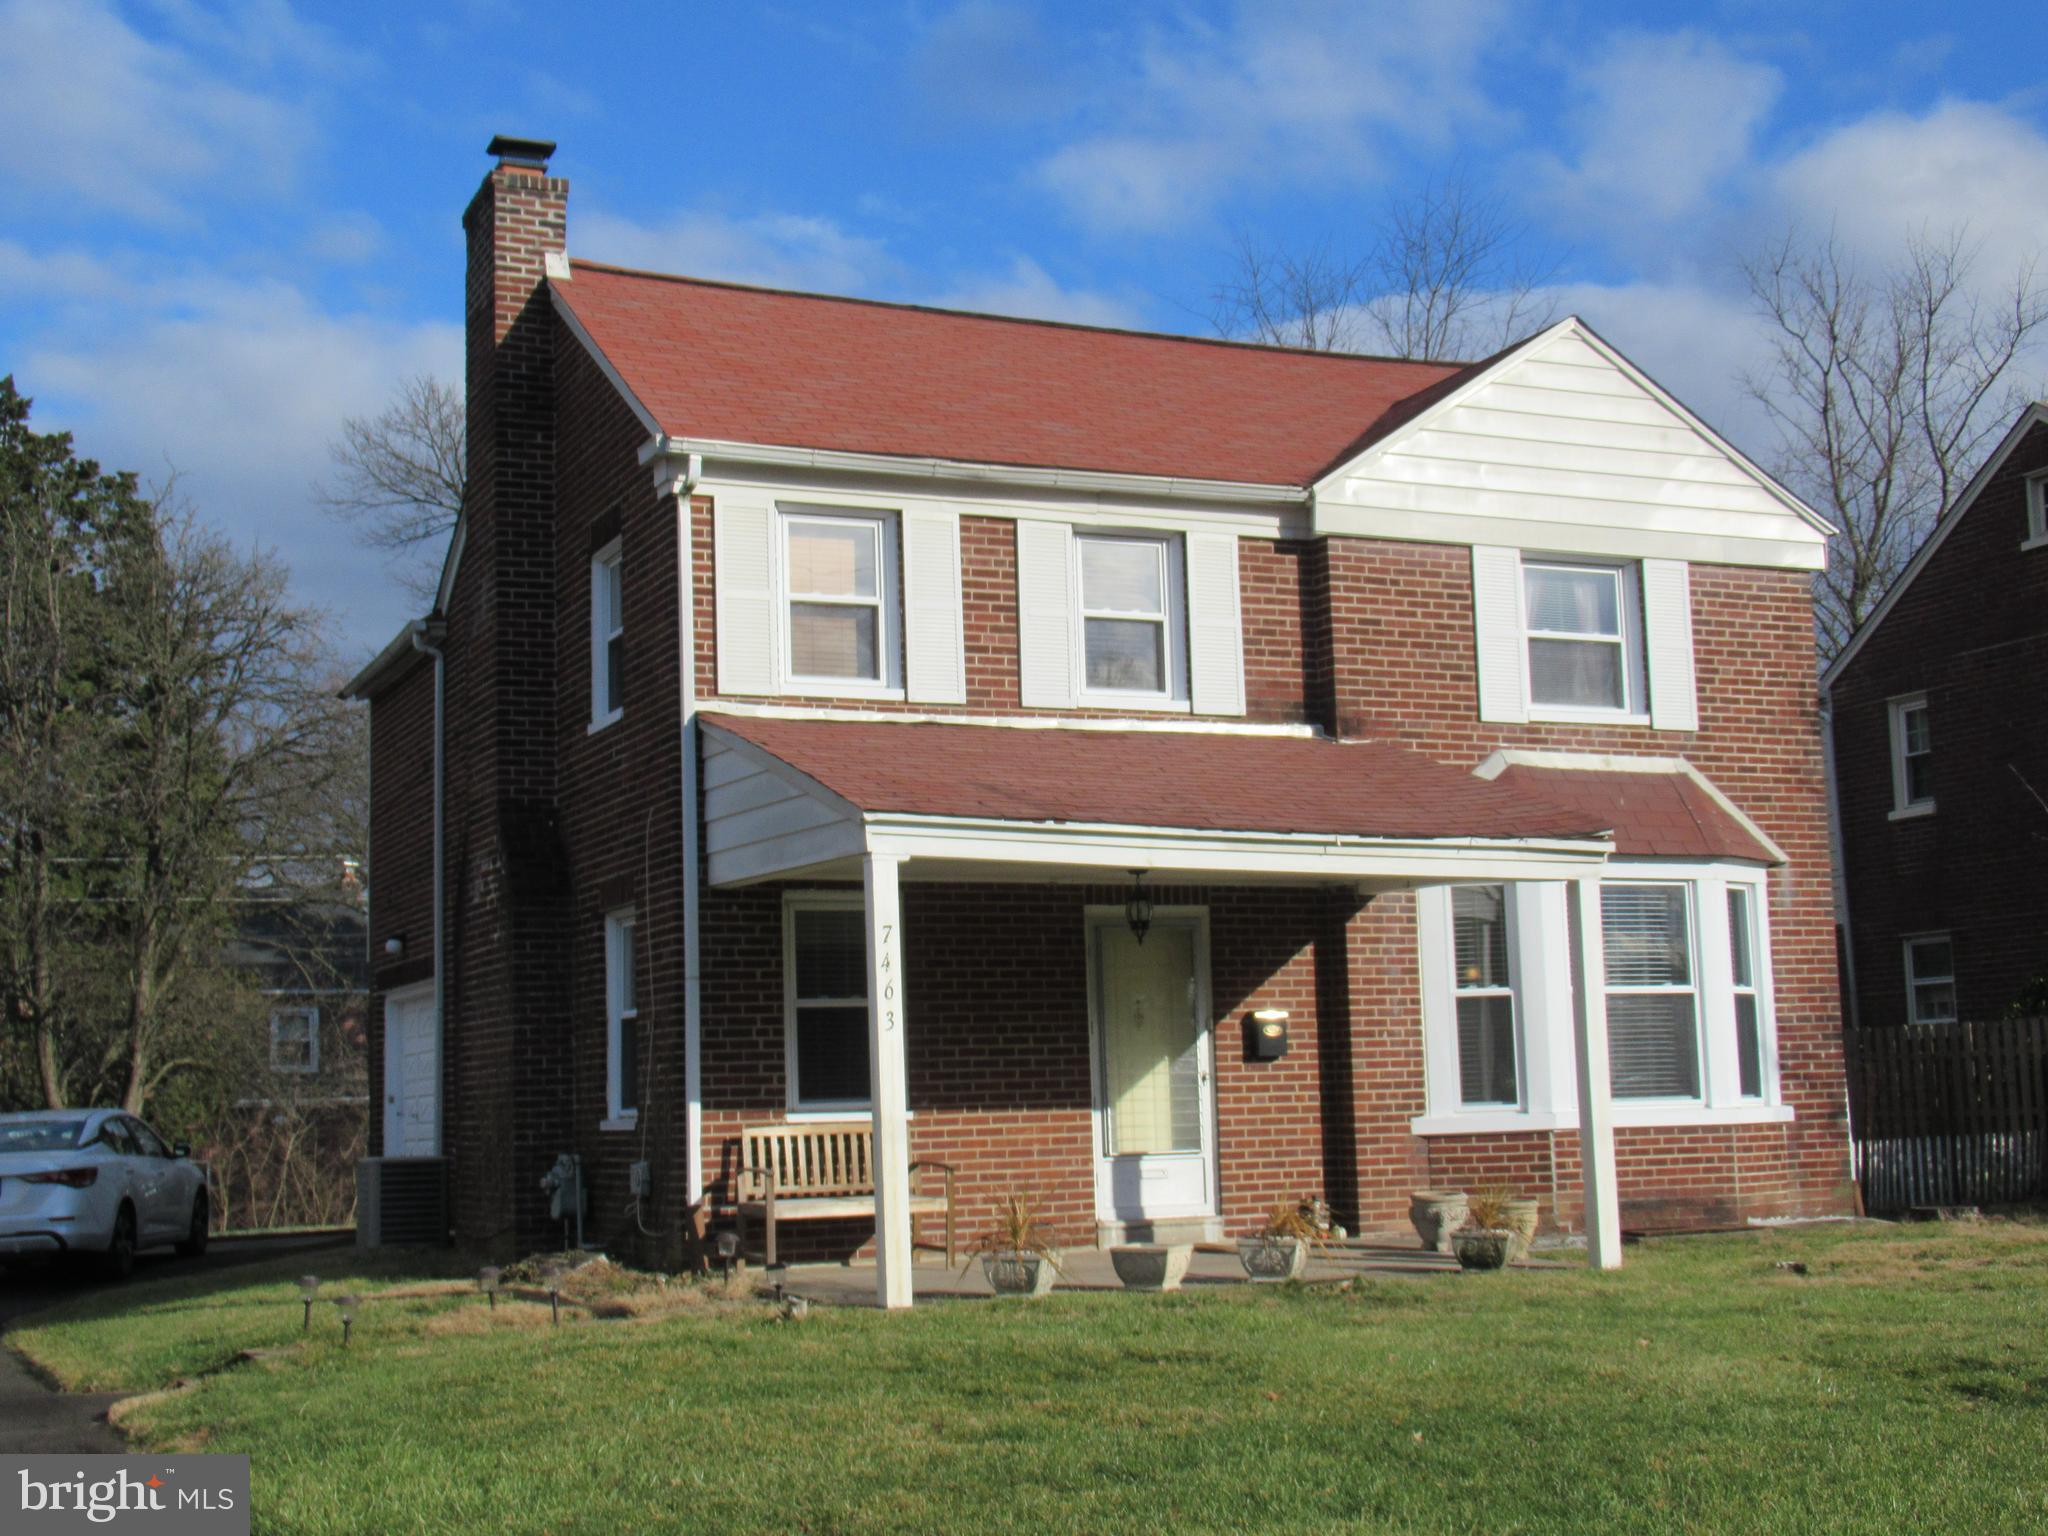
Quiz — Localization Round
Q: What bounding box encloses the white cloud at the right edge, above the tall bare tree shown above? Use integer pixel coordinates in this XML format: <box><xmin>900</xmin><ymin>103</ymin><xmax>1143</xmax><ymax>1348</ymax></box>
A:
<box><xmin>1772</xmin><ymin>100</ymin><xmax>2048</xmax><ymax>285</ymax></box>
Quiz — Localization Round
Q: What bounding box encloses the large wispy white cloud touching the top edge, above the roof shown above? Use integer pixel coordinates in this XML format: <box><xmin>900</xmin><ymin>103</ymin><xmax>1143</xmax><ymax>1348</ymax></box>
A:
<box><xmin>1034</xmin><ymin>0</ymin><xmax>1507</xmax><ymax>231</ymax></box>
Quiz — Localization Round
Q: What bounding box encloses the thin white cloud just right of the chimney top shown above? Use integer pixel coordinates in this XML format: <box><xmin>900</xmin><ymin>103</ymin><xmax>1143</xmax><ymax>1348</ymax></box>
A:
<box><xmin>569</xmin><ymin>209</ymin><xmax>899</xmax><ymax>293</ymax></box>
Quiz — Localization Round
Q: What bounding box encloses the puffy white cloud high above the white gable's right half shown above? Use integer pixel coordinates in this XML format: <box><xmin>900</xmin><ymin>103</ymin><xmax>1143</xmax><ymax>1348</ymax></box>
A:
<box><xmin>1532</xmin><ymin>31</ymin><xmax>1784</xmax><ymax>227</ymax></box>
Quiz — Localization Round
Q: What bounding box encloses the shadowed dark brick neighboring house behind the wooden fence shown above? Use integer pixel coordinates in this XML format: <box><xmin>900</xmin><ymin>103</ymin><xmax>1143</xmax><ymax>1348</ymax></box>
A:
<box><xmin>1821</xmin><ymin>401</ymin><xmax>2048</xmax><ymax>1028</ymax></box>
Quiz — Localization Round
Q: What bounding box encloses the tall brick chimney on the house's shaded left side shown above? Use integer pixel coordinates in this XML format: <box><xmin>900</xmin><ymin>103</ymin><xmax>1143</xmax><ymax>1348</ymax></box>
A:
<box><xmin>442</xmin><ymin>137</ymin><xmax>571</xmax><ymax>1251</ymax></box>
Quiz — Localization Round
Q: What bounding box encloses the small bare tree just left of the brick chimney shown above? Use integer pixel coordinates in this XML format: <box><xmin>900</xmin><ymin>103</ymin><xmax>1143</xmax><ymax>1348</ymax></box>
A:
<box><xmin>313</xmin><ymin>375</ymin><xmax>469</xmax><ymax>598</ymax></box>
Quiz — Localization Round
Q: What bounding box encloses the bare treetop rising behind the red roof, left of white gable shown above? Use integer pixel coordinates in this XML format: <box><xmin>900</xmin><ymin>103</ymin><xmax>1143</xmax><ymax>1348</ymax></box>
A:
<box><xmin>1210</xmin><ymin>176</ymin><xmax>1556</xmax><ymax>362</ymax></box>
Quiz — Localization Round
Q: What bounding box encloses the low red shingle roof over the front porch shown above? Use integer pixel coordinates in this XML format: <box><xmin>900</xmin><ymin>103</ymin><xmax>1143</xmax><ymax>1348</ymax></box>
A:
<box><xmin>705</xmin><ymin>715</ymin><xmax>1608</xmax><ymax>838</ymax></box>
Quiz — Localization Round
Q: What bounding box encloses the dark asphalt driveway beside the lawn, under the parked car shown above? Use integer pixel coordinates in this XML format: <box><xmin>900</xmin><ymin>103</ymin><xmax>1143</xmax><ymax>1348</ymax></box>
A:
<box><xmin>0</xmin><ymin>1233</ymin><xmax>350</xmax><ymax>1454</ymax></box>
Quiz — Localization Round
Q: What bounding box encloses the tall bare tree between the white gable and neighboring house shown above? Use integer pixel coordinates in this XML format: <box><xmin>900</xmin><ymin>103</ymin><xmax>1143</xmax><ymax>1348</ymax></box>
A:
<box><xmin>1743</xmin><ymin>229</ymin><xmax>2048</xmax><ymax>662</ymax></box>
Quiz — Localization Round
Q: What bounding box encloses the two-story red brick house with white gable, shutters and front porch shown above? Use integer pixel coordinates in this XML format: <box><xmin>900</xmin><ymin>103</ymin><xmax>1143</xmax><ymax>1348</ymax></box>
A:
<box><xmin>350</xmin><ymin>141</ymin><xmax>1851</xmax><ymax>1303</ymax></box>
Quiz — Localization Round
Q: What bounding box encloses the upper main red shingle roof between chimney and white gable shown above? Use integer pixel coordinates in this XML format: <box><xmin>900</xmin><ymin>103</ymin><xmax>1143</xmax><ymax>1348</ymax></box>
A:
<box><xmin>551</xmin><ymin>262</ymin><xmax>1464</xmax><ymax>485</ymax></box>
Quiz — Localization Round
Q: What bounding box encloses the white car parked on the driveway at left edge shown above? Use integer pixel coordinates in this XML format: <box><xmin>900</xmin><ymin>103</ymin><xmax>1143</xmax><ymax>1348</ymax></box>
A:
<box><xmin>0</xmin><ymin>1110</ymin><xmax>211</xmax><ymax>1278</ymax></box>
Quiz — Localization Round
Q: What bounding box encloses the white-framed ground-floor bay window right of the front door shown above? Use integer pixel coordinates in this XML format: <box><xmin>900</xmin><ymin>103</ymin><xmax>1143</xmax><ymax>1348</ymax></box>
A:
<box><xmin>1413</xmin><ymin>860</ymin><xmax>1792</xmax><ymax>1135</ymax></box>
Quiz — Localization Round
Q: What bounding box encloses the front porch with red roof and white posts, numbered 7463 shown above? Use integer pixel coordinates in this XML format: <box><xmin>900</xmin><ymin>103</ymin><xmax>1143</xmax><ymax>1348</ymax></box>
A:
<box><xmin>700</xmin><ymin>717</ymin><xmax>1620</xmax><ymax>1307</ymax></box>
